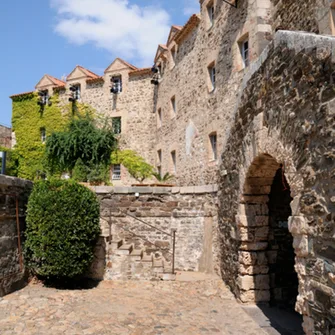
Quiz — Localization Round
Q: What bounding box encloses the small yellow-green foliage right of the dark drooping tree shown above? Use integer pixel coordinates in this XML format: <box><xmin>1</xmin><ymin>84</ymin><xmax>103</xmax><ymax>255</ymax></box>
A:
<box><xmin>112</xmin><ymin>150</ymin><xmax>154</xmax><ymax>182</ymax></box>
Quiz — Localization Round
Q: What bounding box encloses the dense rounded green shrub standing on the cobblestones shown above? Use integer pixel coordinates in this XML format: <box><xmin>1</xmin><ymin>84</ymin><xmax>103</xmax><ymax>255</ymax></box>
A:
<box><xmin>25</xmin><ymin>180</ymin><xmax>100</xmax><ymax>278</ymax></box>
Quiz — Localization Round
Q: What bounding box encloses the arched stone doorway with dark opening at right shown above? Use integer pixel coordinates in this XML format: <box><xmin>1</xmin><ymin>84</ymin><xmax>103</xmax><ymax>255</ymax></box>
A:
<box><xmin>236</xmin><ymin>154</ymin><xmax>300</xmax><ymax>327</ymax></box>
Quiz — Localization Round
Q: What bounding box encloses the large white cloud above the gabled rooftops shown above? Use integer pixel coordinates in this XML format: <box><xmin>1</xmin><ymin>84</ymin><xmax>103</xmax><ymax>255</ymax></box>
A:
<box><xmin>51</xmin><ymin>0</ymin><xmax>170</xmax><ymax>66</ymax></box>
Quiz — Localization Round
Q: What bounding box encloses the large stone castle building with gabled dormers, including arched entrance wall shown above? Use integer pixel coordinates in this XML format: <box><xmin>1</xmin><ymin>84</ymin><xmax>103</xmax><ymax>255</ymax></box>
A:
<box><xmin>9</xmin><ymin>0</ymin><xmax>335</xmax><ymax>334</ymax></box>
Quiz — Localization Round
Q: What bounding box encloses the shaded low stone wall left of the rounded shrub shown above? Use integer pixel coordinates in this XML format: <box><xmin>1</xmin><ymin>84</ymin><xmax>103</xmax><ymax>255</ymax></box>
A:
<box><xmin>0</xmin><ymin>175</ymin><xmax>32</xmax><ymax>296</ymax></box>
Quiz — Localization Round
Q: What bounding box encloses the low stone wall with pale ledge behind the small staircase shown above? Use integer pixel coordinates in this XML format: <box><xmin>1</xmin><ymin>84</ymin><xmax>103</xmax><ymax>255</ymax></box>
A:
<box><xmin>93</xmin><ymin>185</ymin><xmax>218</xmax><ymax>280</ymax></box>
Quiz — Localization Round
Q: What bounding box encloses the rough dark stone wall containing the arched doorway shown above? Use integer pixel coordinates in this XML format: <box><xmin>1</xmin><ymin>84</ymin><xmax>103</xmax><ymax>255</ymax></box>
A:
<box><xmin>219</xmin><ymin>32</ymin><xmax>335</xmax><ymax>334</ymax></box>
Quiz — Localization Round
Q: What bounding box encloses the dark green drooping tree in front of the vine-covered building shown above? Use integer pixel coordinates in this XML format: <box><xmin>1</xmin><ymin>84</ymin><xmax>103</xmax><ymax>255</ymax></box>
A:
<box><xmin>46</xmin><ymin>116</ymin><xmax>116</xmax><ymax>175</ymax></box>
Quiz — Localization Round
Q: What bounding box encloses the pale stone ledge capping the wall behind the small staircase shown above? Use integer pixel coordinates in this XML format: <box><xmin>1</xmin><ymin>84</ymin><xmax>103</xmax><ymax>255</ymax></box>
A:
<box><xmin>94</xmin><ymin>184</ymin><xmax>219</xmax><ymax>195</ymax></box>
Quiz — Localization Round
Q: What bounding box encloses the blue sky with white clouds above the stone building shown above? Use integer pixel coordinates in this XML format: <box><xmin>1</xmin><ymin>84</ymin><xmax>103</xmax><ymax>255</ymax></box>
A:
<box><xmin>0</xmin><ymin>0</ymin><xmax>199</xmax><ymax>125</ymax></box>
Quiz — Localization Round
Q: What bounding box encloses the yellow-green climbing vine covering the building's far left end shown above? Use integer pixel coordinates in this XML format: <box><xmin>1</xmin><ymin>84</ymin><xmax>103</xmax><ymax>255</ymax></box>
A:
<box><xmin>12</xmin><ymin>93</ymin><xmax>93</xmax><ymax>180</ymax></box>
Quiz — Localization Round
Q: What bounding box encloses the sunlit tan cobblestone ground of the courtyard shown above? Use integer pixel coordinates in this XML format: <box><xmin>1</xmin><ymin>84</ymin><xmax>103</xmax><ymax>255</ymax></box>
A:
<box><xmin>0</xmin><ymin>279</ymin><xmax>264</xmax><ymax>335</ymax></box>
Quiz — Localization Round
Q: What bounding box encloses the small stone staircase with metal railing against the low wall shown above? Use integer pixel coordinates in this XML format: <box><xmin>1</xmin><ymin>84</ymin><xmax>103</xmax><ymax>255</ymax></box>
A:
<box><xmin>104</xmin><ymin>238</ymin><xmax>175</xmax><ymax>280</ymax></box>
